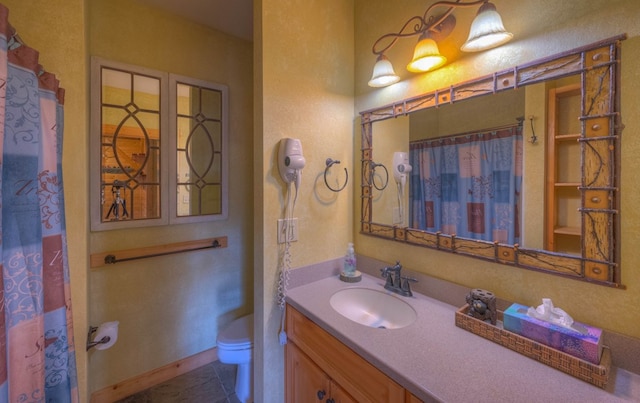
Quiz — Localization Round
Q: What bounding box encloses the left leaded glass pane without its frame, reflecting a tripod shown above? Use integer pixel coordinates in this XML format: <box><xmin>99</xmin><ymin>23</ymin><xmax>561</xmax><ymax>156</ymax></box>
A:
<box><xmin>100</xmin><ymin>67</ymin><xmax>161</xmax><ymax>222</ymax></box>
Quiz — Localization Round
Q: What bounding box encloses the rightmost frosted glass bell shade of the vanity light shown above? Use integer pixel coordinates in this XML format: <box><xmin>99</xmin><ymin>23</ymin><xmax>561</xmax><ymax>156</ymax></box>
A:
<box><xmin>460</xmin><ymin>3</ymin><xmax>513</xmax><ymax>52</ymax></box>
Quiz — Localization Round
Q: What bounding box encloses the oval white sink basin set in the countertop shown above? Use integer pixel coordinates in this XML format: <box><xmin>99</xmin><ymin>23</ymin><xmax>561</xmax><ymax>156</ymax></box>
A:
<box><xmin>329</xmin><ymin>288</ymin><xmax>417</xmax><ymax>329</ymax></box>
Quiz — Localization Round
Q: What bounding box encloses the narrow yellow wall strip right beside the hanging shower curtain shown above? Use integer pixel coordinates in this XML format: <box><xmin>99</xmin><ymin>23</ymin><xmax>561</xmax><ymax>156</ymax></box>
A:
<box><xmin>2</xmin><ymin>0</ymin><xmax>89</xmax><ymax>401</ymax></box>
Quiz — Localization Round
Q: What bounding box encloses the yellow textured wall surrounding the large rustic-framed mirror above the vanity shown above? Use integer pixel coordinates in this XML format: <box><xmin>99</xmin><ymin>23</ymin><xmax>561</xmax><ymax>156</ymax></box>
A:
<box><xmin>354</xmin><ymin>0</ymin><xmax>640</xmax><ymax>337</ymax></box>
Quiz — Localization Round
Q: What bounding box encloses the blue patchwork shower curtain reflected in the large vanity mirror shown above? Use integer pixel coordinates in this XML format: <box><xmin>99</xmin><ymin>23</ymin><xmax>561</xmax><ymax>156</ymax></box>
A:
<box><xmin>409</xmin><ymin>125</ymin><xmax>522</xmax><ymax>244</ymax></box>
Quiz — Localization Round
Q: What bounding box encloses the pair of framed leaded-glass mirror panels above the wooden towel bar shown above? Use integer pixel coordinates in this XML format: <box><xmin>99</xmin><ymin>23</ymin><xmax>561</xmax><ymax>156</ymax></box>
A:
<box><xmin>91</xmin><ymin>58</ymin><xmax>227</xmax><ymax>230</ymax></box>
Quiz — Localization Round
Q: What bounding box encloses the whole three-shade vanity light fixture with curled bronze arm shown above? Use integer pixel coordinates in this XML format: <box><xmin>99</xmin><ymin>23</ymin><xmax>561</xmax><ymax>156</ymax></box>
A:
<box><xmin>369</xmin><ymin>0</ymin><xmax>513</xmax><ymax>87</ymax></box>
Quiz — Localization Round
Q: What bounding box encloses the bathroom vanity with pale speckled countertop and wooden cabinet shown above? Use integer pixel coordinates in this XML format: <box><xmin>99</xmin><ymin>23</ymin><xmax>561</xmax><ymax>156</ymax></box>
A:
<box><xmin>285</xmin><ymin>274</ymin><xmax>640</xmax><ymax>402</ymax></box>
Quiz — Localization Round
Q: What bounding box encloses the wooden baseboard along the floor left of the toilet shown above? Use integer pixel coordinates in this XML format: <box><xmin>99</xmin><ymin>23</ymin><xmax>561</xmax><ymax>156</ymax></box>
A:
<box><xmin>91</xmin><ymin>347</ymin><xmax>218</xmax><ymax>403</ymax></box>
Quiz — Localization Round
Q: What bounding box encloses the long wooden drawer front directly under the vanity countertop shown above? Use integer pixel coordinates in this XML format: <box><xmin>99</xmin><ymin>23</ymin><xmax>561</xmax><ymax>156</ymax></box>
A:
<box><xmin>287</xmin><ymin>305</ymin><xmax>405</xmax><ymax>403</ymax></box>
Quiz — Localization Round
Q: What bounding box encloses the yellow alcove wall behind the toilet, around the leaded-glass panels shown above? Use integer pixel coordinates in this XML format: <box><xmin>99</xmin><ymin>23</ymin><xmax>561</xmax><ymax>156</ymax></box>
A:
<box><xmin>85</xmin><ymin>0</ymin><xmax>253</xmax><ymax>391</ymax></box>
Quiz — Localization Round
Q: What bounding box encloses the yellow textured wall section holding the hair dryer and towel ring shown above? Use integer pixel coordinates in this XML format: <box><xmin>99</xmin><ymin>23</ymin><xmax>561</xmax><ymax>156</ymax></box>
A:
<box><xmin>254</xmin><ymin>0</ymin><xmax>355</xmax><ymax>402</ymax></box>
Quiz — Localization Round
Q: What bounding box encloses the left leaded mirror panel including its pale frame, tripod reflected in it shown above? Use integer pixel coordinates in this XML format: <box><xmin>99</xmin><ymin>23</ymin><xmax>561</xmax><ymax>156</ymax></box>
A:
<box><xmin>91</xmin><ymin>58</ymin><xmax>168</xmax><ymax>230</ymax></box>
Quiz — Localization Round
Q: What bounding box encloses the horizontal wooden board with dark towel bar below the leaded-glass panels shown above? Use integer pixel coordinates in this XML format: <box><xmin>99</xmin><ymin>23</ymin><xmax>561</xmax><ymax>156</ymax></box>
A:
<box><xmin>90</xmin><ymin>236</ymin><xmax>227</xmax><ymax>268</ymax></box>
